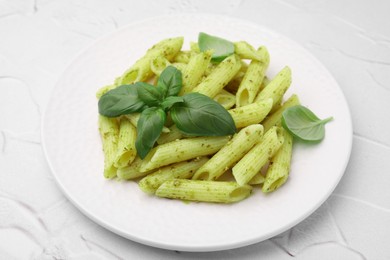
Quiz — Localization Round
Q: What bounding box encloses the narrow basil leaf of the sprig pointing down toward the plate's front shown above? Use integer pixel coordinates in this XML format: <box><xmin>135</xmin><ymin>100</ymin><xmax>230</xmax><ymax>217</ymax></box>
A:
<box><xmin>135</xmin><ymin>107</ymin><xmax>166</xmax><ymax>159</ymax></box>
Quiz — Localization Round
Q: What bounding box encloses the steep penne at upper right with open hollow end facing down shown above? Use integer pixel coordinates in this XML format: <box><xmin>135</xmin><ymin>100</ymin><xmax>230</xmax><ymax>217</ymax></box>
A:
<box><xmin>236</xmin><ymin>46</ymin><xmax>269</xmax><ymax>107</ymax></box>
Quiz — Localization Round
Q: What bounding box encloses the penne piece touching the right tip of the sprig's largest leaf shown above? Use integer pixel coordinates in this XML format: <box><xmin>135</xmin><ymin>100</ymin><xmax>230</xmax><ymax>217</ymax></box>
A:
<box><xmin>228</xmin><ymin>99</ymin><xmax>272</xmax><ymax>128</ymax></box>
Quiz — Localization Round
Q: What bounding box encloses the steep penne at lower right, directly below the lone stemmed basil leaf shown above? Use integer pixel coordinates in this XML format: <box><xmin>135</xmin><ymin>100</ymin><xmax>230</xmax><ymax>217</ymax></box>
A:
<box><xmin>262</xmin><ymin>131</ymin><xmax>293</xmax><ymax>192</ymax></box>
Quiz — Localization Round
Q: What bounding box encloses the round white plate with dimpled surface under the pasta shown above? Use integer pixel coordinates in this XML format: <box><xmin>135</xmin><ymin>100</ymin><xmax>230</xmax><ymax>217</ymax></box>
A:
<box><xmin>42</xmin><ymin>14</ymin><xmax>352</xmax><ymax>251</ymax></box>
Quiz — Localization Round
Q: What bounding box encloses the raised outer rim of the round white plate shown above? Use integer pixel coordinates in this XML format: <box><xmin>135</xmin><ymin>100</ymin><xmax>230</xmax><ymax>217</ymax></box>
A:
<box><xmin>40</xmin><ymin>12</ymin><xmax>353</xmax><ymax>252</ymax></box>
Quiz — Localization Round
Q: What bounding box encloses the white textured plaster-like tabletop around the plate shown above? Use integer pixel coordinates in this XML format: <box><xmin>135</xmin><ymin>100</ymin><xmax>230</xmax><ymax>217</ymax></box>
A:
<box><xmin>0</xmin><ymin>0</ymin><xmax>390</xmax><ymax>260</ymax></box>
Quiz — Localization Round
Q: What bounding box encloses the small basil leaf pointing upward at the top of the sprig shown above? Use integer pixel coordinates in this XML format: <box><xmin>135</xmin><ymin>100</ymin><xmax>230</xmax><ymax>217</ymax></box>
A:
<box><xmin>157</xmin><ymin>66</ymin><xmax>182</xmax><ymax>97</ymax></box>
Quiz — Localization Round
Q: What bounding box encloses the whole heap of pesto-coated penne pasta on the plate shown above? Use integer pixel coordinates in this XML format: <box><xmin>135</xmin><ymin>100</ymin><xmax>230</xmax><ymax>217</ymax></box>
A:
<box><xmin>97</xmin><ymin>37</ymin><xmax>299</xmax><ymax>203</ymax></box>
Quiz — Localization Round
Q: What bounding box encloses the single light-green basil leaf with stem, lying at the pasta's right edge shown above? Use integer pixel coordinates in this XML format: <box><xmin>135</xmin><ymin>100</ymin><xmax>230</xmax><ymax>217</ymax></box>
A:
<box><xmin>282</xmin><ymin>105</ymin><xmax>333</xmax><ymax>142</ymax></box>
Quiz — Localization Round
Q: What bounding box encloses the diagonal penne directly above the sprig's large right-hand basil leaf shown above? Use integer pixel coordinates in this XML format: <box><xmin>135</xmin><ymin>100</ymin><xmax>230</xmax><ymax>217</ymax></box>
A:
<box><xmin>192</xmin><ymin>55</ymin><xmax>241</xmax><ymax>98</ymax></box>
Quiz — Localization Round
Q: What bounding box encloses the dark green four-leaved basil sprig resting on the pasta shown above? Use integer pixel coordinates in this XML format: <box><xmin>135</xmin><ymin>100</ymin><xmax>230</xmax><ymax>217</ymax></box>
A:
<box><xmin>98</xmin><ymin>66</ymin><xmax>236</xmax><ymax>159</ymax></box>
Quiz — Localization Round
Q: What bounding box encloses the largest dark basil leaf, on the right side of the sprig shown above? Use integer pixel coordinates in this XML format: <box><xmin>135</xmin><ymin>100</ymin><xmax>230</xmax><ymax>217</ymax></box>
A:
<box><xmin>170</xmin><ymin>93</ymin><xmax>236</xmax><ymax>136</ymax></box>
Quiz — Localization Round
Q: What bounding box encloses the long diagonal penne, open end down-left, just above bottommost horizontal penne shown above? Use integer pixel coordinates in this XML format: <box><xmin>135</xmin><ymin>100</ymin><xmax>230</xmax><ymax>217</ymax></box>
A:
<box><xmin>192</xmin><ymin>124</ymin><xmax>263</xmax><ymax>180</ymax></box>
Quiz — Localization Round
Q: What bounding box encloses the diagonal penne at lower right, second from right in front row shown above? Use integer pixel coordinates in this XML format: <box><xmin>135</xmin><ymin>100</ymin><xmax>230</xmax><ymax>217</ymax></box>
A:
<box><xmin>232</xmin><ymin>126</ymin><xmax>284</xmax><ymax>185</ymax></box>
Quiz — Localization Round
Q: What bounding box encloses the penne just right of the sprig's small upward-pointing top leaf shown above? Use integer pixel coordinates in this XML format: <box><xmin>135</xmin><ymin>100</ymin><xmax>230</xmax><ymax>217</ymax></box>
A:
<box><xmin>179</xmin><ymin>51</ymin><xmax>212</xmax><ymax>96</ymax></box>
